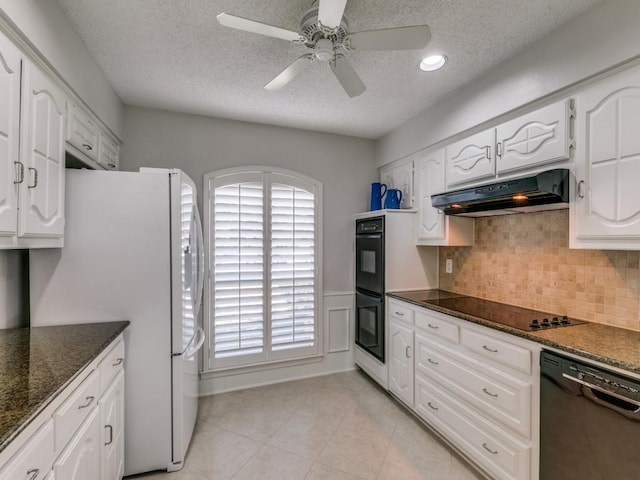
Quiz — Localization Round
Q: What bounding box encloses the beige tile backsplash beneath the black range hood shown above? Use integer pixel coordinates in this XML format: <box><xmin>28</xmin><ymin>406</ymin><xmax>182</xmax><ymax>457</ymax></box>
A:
<box><xmin>439</xmin><ymin>210</ymin><xmax>640</xmax><ymax>330</ymax></box>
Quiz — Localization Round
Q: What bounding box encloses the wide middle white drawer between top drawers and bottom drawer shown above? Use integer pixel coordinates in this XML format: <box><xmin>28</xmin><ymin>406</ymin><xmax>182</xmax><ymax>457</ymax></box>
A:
<box><xmin>416</xmin><ymin>335</ymin><xmax>531</xmax><ymax>438</ymax></box>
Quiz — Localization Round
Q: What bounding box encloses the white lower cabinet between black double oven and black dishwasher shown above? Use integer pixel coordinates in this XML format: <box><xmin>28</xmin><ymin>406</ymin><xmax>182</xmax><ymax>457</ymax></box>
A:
<box><xmin>387</xmin><ymin>298</ymin><xmax>540</xmax><ymax>480</ymax></box>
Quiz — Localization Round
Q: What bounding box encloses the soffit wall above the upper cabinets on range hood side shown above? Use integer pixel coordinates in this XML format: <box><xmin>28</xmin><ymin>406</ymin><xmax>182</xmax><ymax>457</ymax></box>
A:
<box><xmin>376</xmin><ymin>0</ymin><xmax>640</xmax><ymax>166</ymax></box>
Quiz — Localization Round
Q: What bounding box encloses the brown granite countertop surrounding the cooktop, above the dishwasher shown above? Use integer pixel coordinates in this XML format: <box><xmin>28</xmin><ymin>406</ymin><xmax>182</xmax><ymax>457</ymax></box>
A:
<box><xmin>387</xmin><ymin>290</ymin><xmax>640</xmax><ymax>374</ymax></box>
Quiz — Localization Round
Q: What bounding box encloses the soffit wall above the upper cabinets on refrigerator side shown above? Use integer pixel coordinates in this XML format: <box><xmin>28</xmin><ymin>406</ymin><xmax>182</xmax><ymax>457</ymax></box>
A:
<box><xmin>0</xmin><ymin>0</ymin><xmax>122</xmax><ymax>138</ymax></box>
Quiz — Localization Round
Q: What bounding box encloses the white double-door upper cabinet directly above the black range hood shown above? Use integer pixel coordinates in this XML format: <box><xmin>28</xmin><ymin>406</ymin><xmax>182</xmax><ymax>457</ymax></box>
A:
<box><xmin>446</xmin><ymin>100</ymin><xmax>574</xmax><ymax>190</ymax></box>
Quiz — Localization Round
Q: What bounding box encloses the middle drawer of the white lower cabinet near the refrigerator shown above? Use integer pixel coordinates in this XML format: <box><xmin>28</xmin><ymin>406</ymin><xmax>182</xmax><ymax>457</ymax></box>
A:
<box><xmin>53</xmin><ymin>370</ymin><xmax>100</xmax><ymax>452</ymax></box>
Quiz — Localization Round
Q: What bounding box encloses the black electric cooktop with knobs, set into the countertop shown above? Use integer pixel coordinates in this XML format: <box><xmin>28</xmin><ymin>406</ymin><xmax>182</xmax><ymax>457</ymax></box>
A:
<box><xmin>424</xmin><ymin>296</ymin><xmax>585</xmax><ymax>332</ymax></box>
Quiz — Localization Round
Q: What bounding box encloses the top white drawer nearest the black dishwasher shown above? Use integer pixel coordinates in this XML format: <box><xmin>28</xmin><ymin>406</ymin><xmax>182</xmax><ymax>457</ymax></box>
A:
<box><xmin>462</xmin><ymin>329</ymin><xmax>531</xmax><ymax>374</ymax></box>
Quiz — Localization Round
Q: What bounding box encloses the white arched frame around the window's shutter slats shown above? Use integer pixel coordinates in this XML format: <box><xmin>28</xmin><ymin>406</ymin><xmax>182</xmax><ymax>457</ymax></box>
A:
<box><xmin>202</xmin><ymin>165</ymin><xmax>324</xmax><ymax>372</ymax></box>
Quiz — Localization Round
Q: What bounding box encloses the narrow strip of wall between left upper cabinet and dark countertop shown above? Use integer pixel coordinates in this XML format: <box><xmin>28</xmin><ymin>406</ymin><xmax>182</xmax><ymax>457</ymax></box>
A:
<box><xmin>0</xmin><ymin>250</ymin><xmax>26</xmax><ymax>329</ymax></box>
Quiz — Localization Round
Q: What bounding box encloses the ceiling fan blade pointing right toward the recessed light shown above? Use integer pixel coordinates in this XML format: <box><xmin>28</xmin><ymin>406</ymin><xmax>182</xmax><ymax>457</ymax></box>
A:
<box><xmin>347</xmin><ymin>25</ymin><xmax>431</xmax><ymax>50</ymax></box>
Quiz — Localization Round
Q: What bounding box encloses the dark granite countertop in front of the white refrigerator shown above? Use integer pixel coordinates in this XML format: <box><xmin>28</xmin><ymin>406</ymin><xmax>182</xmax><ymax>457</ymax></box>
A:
<box><xmin>0</xmin><ymin>321</ymin><xmax>129</xmax><ymax>451</ymax></box>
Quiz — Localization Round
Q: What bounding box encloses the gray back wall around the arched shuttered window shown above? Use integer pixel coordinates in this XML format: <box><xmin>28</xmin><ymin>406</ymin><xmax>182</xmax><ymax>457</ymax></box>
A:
<box><xmin>121</xmin><ymin>107</ymin><xmax>377</xmax><ymax>292</ymax></box>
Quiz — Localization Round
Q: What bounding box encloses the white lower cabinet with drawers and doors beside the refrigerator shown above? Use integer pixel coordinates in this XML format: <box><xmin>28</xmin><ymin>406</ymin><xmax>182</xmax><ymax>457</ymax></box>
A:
<box><xmin>0</xmin><ymin>336</ymin><xmax>124</xmax><ymax>480</ymax></box>
